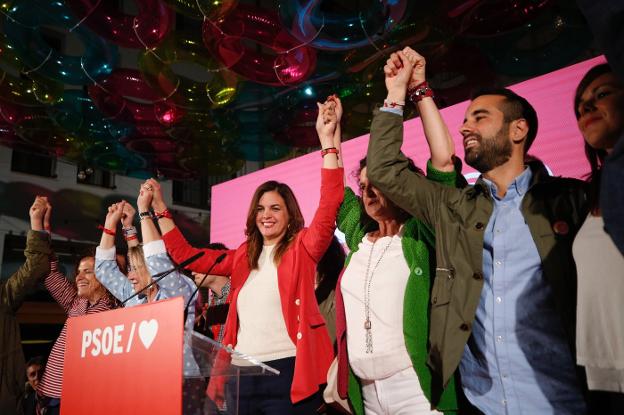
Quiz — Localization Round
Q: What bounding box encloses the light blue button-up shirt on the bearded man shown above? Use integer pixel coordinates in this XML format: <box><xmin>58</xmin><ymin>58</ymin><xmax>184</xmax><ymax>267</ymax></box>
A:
<box><xmin>459</xmin><ymin>168</ymin><xmax>586</xmax><ymax>415</ymax></box>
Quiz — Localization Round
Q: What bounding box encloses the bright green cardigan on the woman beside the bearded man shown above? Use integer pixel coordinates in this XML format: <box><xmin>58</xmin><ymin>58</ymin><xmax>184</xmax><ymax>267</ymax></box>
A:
<box><xmin>337</xmin><ymin>163</ymin><xmax>457</xmax><ymax>415</ymax></box>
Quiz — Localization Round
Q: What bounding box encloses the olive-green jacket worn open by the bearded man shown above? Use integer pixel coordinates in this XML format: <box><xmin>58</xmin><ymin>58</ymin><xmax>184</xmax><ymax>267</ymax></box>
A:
<box><xmin>367</xmin><ymin>111</ymin><xmax>588</xmax><ymax>384</ymax></box>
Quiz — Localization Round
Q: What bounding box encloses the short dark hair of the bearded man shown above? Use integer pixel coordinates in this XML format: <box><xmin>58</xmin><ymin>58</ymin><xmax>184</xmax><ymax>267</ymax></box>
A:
<box><xmin>471</xmin><ymin>88</ymin><xmax>538</xmax><ymax>154</ymax></box>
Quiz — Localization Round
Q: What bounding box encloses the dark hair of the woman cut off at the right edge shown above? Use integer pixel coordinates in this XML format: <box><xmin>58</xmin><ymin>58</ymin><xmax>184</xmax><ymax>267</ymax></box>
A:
<box><xmin>574</xmin><ymin>63</ymin><xmax>613</xmax><ymax>214</ymax></box>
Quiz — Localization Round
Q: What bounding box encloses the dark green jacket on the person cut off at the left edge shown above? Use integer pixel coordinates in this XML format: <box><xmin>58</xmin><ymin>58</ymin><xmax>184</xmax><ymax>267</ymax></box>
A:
<box><xmin>0</xmin><ymin>231</ymin><xmax>50</xmax><ymax>414</ymax></box>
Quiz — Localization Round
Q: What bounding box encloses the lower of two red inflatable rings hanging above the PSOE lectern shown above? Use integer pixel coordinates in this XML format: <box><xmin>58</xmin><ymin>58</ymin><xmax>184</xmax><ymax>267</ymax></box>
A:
<box><xmin>88</xmin><ymin>68</ymin><xmax>184</xmax><ymax>126</ymax></box>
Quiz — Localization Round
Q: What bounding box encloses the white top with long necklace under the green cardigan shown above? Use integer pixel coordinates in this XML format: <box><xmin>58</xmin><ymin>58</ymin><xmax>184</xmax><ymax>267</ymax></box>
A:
<box><xmin>340</xmin><ymin>235</ymin><xmax>412</xmax><ymax>380</ymax></box>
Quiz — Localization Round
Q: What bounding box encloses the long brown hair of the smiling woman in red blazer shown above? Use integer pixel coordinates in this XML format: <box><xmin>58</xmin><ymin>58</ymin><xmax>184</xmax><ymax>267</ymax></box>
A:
<box><xmin>245</xmin><ymin>180</ymin><xmax>304</xmax><ymax>269</ymax></box>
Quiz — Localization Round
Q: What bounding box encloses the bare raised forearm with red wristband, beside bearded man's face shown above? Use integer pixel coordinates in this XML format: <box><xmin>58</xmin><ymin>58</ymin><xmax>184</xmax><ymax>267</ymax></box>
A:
<box><xmin>402</xmin><ymin>47</ymin><xmax>455</xmax><ymax>172</ymax></box>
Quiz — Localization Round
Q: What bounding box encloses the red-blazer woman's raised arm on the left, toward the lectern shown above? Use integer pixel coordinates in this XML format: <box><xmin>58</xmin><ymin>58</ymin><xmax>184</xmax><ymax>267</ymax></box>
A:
<box><xmin>141</xmin><ymin>179</ymin><xmax>236</xmax><ymax>276</ymax></box>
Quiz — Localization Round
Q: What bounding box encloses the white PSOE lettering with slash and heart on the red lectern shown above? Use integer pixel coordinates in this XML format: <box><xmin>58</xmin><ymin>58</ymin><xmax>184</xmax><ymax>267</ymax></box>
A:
<box><xmin>80</xmin><ymin>319</ymin><xmax>158</xmax><ymax>358</ymax></box>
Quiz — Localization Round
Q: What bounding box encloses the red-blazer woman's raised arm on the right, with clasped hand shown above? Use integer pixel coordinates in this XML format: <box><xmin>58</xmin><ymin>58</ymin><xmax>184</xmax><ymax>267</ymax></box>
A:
<box><xmin>302</xmin><ymin>96</ymin><xmax>344</xmax><ymax>262</ymax></box>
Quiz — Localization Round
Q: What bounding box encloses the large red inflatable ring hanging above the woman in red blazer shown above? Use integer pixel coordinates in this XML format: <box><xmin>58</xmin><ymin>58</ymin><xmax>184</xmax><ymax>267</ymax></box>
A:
<box><xmin>203</xmin><ymin>4</ymin><xmax>316</xmax><ymax>86</ymax></box>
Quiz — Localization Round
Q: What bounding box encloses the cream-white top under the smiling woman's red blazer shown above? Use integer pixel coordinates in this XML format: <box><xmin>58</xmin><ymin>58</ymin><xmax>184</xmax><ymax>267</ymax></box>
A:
<box><xmin>235</xmin><ymin>245</ymin><xmax>296</xmax><ymax>364</ymax></box>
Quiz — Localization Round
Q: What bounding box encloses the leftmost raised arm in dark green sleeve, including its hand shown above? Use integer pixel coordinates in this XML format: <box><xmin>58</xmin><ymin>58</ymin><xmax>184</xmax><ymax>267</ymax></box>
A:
<box><xmin>0</xmin><ymin>196</ymin><xmax>51</xmax><ymax>312</ymax></box>
